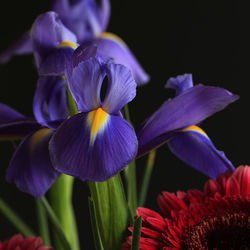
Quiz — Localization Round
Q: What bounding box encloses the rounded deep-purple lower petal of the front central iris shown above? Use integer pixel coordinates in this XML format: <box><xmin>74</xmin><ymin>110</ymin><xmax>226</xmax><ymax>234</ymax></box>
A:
<box><xmin>49</xmin><ymin>113</ymin><xmax>137</xmax><ymax>181</ymax></box>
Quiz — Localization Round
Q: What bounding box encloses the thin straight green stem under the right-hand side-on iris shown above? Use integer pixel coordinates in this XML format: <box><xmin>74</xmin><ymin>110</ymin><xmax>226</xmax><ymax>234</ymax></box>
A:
<box><xmin>139</xmin><ymin>150</ymin><xmax>156</xmax><ymax>207</ymax></box>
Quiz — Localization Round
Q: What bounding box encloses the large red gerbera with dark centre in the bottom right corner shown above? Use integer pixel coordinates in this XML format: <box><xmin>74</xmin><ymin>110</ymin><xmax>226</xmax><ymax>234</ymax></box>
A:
<box><xmin>123</xmin><ymin>166</ymin><xmax>250</xmax><ymax>250</ymax></box>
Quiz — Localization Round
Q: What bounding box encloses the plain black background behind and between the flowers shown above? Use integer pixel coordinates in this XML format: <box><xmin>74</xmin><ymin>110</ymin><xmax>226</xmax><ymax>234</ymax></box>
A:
<box><xmin>0</xmin><ymin>0</ymin><xmax>247</xmax><ymax>249</ymax></box>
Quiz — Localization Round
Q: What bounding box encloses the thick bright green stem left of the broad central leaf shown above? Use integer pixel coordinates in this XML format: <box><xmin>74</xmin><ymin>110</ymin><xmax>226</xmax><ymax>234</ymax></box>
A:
<box><xmin>50</xmin><ymin>175</ymin><xmax>80</xmax><ymax>250</ymax></box>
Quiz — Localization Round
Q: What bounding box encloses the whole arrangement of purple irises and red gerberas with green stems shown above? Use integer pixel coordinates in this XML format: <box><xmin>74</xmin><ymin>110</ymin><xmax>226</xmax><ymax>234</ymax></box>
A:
<box><xmin>0</xmin><ymin>0</ymin><xmax>247</xmax><ymax>250</ymax></box>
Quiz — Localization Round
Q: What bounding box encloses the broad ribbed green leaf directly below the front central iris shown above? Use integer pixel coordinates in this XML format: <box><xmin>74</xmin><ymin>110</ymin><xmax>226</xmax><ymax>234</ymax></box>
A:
<box><xmin>88</xmin><ymin>174</ymin><xmax>129</xmax><ymax>250</ymax></box>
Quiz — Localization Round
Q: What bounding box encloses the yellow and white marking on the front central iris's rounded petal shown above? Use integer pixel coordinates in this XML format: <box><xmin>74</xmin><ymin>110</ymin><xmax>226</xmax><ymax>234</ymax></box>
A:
<box><xmin>87</xmin><ymin>108</ymin><xmax>109</xmax><ymax>145</ymax></box>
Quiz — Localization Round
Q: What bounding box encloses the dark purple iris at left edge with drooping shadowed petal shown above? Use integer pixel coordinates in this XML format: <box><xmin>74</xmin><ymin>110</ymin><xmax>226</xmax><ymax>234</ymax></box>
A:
<box><xmin>0</xmin><ymin>104</ymin><xmax>60</xmax><ymax>198</ymax></box>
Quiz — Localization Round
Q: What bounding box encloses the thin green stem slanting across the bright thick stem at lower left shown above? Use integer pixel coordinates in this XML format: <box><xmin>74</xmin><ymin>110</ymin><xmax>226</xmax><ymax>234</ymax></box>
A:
<box><xmin>41</xmin><ymin>197</ymin><xmax>71</xmax><ymax>250</ymax></box>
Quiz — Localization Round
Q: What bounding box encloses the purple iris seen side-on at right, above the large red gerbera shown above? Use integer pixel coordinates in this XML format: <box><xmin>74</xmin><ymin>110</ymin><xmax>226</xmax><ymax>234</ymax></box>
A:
<box><xmin>137</xmin><ymin>74</ymin><xmax>238</xmax><ymax>178</ymax></box>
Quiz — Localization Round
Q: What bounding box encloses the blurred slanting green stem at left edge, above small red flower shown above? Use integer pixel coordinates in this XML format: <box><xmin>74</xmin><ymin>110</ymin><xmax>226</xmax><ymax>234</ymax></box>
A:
<box><xmin>0</xmin><ymin>198</ymin><xmax>35</xmax><ymax>236</ymax></box>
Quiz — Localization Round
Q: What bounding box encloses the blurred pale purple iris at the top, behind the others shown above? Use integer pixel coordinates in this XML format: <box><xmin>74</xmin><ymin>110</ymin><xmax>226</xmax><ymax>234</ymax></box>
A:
<box><xmin>0</xmin><ymin>0</ymin><xmax>149</xmax><ymax>84</ymax></box>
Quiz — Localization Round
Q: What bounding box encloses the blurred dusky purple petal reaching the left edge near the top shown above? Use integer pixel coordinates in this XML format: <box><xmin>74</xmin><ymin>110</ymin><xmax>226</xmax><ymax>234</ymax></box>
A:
<box><xmin>0</xmin><ymin>32</ymin><xmax>33</xmax><ymax>64</ymax></box>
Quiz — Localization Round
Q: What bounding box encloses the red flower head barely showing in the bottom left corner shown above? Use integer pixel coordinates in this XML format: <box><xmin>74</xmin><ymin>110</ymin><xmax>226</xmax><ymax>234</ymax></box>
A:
<box><xmin>0</xmin><ymin>234</ymin><xmax>53</xmax><ymax>250</ymax></box>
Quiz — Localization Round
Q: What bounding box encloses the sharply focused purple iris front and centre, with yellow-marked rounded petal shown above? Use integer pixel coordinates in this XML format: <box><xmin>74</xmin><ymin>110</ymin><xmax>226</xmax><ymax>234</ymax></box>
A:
<box><xmin>49</xmin><ymin>58</ymin><xmax>137</xmax><ymax>181</ymax></box>
